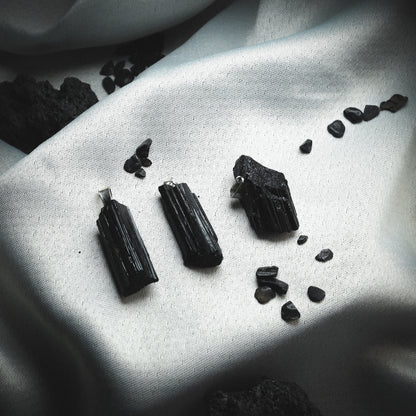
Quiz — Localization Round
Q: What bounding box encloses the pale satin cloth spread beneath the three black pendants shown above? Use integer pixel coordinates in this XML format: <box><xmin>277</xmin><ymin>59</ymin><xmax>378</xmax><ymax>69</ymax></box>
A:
<box><xmin>0</xmin><ymin>0</ymin><xmax>416</xmax><ymax>416</ymax></box>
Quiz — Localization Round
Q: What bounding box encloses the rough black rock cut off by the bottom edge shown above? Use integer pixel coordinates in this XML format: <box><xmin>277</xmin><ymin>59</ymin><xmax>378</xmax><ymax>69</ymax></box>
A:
<box><xmin>208</xmin><ymin>379</ymin><xmax>321</xmax><ymax>416</ymax></box>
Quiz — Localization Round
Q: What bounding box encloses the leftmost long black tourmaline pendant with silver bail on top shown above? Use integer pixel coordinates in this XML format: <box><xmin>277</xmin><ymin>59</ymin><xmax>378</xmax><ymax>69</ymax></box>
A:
<box><xmin>97</xmin><ymin>188</ymin><xmax>159</xmax><ymax>296</ymax></box>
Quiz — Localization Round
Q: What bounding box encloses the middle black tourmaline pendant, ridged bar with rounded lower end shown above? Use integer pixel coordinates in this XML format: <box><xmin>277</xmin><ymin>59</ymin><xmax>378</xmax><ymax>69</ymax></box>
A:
<box><xmin>159</xmin><ymin>181</ymin><xmax>223</xmax><ymax>267</ymax></box>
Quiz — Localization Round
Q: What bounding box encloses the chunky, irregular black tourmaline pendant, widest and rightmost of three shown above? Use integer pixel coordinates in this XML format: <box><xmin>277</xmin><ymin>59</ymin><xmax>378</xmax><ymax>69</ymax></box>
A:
<box><xmin>231</xmin><ymin>156</ymin><xmax>299</xmax><ymax>234</ymax></box>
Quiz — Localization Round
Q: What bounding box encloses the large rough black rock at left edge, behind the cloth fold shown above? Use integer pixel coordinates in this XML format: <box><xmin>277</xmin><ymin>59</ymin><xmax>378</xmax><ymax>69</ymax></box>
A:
<box><xmin>0</xmin><ymin>75</ymin><xmax>98</xmax><ymax>153</ymax></box>
